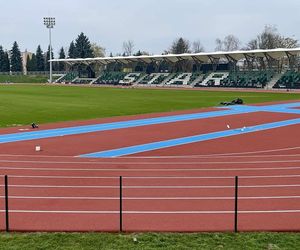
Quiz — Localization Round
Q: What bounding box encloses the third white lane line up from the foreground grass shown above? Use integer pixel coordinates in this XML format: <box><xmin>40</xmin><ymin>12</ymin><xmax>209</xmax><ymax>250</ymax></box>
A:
<box><xmin>0</xmin><ymin>184</ymin><xmax>300</xmax><ymax>189</ymax></box>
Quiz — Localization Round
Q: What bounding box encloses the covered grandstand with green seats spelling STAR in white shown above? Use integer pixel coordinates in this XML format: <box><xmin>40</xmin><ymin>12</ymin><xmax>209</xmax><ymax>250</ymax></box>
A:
<box><xmin>52</xmin><ymin>48</ymin><xmax>300</xmax><ymax>89</ymax></box>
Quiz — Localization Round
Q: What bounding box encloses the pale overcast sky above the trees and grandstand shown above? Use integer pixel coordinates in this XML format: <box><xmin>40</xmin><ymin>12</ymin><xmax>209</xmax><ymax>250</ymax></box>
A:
<box><xmin>0</xmin><ymin>0</ymin><xmax>300</xmax><ymax>57</ymax></box>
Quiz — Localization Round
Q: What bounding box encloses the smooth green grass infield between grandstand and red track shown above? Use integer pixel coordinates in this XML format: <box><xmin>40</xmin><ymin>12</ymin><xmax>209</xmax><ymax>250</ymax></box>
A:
<box><xmin>0</xmin><ymin>84</ymin><xmax>300</xmax><ymax>127</ymax></box>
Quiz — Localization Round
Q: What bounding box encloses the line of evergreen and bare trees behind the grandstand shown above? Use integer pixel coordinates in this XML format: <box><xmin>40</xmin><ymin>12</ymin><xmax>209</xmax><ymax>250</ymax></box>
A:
<box><xmin>0</xmin><ymin>25</ymin><xmax>299</xmax><ymax>72</ymax></box>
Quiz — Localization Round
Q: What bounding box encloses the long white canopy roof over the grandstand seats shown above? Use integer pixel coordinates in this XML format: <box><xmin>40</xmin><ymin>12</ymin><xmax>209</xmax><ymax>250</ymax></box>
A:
<box><xmin>51</xmin><ymin>48</ymin><xmax>300</xmax><ymax>65</ymax></box>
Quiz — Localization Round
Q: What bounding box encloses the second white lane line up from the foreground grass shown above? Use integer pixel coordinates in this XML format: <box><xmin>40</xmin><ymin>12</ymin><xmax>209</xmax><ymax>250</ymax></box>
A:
<box><xmin>0</xmin><ymin>195</ymin><xmax>300</xmax><ymax>201</ymax></box>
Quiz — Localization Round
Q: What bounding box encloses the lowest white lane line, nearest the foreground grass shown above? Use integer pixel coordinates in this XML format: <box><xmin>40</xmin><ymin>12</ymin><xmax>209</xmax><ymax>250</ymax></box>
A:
<box><xmin>0</xmin><ymin>210</ymin><xmax>300</xmax><ymax>215</ymax></box>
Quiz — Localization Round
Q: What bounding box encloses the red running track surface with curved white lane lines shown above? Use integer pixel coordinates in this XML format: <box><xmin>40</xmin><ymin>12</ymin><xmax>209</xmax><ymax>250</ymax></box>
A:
<box><xmin>0</xmin><ymin>102</ymin><xmax>300</xmax><ymax>232</ymax></box>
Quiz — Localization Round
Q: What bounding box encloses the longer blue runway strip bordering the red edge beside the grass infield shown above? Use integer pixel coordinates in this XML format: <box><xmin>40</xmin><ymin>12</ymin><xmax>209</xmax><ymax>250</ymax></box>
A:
<box><xmin>0</xmin><ymin>102</ymin><xmax>300</xmax><ymax>144</ymax></box>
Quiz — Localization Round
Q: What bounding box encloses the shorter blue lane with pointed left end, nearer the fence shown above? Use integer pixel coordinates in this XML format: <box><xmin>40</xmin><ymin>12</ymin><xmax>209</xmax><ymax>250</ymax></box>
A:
<box><xmin>80</xmin><ymin>118</ymin><xmax>300</xmax><ymax>158</ymax></box>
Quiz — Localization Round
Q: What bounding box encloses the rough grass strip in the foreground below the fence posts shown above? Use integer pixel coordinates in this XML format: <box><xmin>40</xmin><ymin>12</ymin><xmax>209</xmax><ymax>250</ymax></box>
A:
<box><xmin>0</xmin><ymin>233</ymin><xmax>300</xmax><ymax>250</ymax></box>
